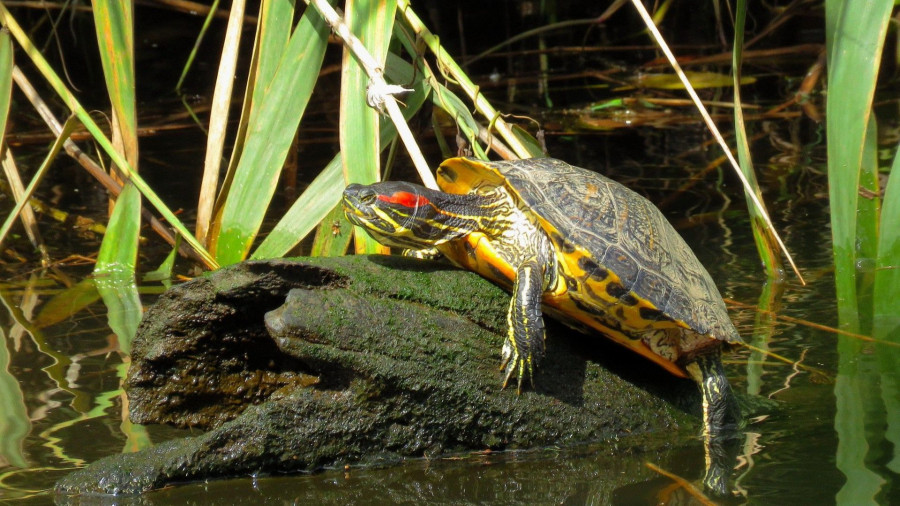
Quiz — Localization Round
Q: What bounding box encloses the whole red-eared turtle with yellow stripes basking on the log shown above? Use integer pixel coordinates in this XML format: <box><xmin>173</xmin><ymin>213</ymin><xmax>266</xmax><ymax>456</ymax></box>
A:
<box><xmin>343</xmin><ymin>158</ymin><xmax>741</xmax><ymax>434</ymax></box>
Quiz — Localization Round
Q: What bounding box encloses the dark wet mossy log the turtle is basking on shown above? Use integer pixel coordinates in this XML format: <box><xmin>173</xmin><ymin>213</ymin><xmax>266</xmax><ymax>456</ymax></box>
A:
<box><xmin>57</xmin><ymin>256</ymin><xmax>699</xmax><ymax>494</ymax></box>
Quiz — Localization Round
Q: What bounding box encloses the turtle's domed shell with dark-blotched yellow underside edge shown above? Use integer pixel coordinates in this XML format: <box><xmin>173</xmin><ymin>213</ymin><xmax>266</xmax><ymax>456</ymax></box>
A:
<box><xmin>438</xmin><ymin>158</ymin><xmax>741</xmax><ymax>369</ymax></box>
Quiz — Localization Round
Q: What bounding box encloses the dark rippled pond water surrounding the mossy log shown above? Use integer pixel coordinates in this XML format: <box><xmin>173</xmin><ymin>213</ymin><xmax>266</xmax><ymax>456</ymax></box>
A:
<box><xmin>0</xmin><ymin>124</ymin><xmax>900</xmax><ymax>504</ymax></box>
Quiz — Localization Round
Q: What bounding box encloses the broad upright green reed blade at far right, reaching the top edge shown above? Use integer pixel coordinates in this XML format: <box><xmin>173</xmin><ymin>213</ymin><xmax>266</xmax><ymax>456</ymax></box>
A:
<box><xmin>825</xmin><ymin>1</ymin><xmax>893</xmax><ymax>329</ymax></box>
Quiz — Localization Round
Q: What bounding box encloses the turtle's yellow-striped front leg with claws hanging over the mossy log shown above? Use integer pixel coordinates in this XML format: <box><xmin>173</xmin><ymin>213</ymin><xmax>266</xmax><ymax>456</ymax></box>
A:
<box><xmin>500</xmin><ymin>258</ymin><xmax>544</xmax><ymax>393</ymax></box>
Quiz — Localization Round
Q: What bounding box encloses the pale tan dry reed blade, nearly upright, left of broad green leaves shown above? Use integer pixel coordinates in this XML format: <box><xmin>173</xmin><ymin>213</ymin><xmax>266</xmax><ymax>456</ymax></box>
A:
<box><xmin>195</xmin><ymin>0</ymin><xmax>246</xmax><ymax>244</ymax></box>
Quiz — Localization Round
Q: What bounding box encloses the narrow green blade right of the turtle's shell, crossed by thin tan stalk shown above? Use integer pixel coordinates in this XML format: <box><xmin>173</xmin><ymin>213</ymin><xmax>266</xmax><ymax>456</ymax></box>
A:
<box><xmin>731</xmin><ymin>0</ymin><xmax>783</xmax><ymax>279</ymax></box>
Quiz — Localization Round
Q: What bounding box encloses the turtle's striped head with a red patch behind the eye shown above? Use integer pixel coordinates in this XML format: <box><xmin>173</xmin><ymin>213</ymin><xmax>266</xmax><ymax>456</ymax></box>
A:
<box><xmin>343</xmin><ymin>181</ymin><xmax>472</xmax><ymax>249</ymax></box>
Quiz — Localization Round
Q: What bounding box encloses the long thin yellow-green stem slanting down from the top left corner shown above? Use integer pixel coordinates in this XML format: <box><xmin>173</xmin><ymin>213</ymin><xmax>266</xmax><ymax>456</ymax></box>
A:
<box><xmin>0</xmin><ymin>3</ymin><xmax>218</xmax><ymax>269</ymax></box>
